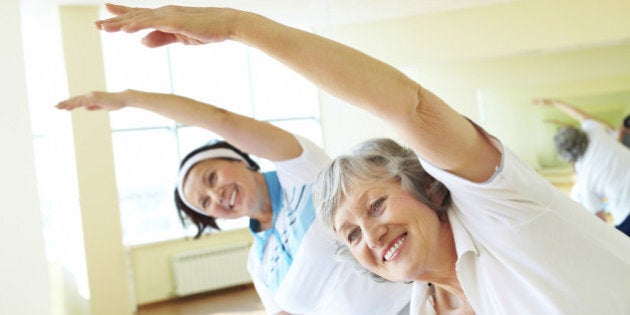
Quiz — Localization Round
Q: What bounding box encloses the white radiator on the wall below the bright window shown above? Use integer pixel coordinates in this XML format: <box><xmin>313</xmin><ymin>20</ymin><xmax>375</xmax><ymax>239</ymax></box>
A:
<box><xmin>172</xmin><ymin>242</ymin><xmax>252</xmax><ymax>296</ymax></box>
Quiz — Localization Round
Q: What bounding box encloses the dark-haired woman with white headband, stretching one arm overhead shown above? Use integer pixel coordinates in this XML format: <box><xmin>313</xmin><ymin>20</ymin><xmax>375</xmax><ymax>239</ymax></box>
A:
<box><xmin>57</xmin><ymin>90</ymin><xmax>411</xmax><ymax>315</ymax></box>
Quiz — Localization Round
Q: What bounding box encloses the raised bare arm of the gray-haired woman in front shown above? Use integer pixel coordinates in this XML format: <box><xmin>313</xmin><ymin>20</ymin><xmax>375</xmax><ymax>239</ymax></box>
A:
<box><xmin>96</xmin><ymin>6</ymin><xmax>500</xmax><ymax>181</ymax></box>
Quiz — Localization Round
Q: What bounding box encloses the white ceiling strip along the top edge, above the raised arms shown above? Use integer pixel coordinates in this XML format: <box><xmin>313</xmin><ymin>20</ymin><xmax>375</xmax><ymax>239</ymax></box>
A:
<box><xmin>21</xmin><ymin>0</ymin><xmax>514</xmax><ymax>26</ymax></box>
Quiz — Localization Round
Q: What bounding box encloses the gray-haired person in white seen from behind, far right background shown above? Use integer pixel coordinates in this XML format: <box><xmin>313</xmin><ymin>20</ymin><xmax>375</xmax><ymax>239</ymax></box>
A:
<box><xmin>534</xmin><ymin>98</ymin><xmax>630</xmax><ymax>236</ymax></box>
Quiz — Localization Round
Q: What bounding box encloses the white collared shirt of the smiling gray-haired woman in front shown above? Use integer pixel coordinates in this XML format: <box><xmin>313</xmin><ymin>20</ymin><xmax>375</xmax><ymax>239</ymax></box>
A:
<box><xmin>411</xmin><ymin>137</ymin><xmax>630</xmax><ymax>315</ymax></box>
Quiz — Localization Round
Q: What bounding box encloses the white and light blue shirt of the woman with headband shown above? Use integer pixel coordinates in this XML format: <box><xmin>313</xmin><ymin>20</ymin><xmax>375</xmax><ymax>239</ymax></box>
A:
<box><xmin>248</xmin><ymin>137</ymin><xmax>412</xmax><ymax>315</ymax></box>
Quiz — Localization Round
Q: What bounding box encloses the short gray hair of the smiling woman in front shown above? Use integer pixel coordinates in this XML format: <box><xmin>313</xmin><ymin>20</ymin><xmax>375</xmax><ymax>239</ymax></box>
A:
<box><xmin>313</xmin><ymin>138</ymin><xmax>451</xmax><ymax>281</ymax></box>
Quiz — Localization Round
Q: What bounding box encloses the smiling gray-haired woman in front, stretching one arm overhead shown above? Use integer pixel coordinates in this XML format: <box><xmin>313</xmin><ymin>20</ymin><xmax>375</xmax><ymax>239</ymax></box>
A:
<box><xmin>91</xmin><ymin>5</ymin><xmax>630</xmax><ymax>314</ymax></box>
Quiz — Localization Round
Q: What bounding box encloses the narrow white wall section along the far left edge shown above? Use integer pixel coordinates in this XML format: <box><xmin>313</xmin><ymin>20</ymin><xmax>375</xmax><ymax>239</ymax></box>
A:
<box><xmin>0</xmin><ymin>0</ymin><xmax>50</xmax><ymax>315</ymax></box>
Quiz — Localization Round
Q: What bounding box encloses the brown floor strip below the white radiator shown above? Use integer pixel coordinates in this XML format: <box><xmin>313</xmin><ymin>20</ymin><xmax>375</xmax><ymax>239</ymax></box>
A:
<box><xmin>135</xmin><ymin>285</ymin><xmax>265</xmax><ymax>315</ymax></box>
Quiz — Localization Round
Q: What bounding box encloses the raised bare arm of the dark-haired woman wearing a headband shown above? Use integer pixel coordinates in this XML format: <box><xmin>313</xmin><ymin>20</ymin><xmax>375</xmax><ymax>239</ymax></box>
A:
<box><xmin>56</xmin><ymin>90</ymin><xmax>302</xmax><ymax>161</ymax></box>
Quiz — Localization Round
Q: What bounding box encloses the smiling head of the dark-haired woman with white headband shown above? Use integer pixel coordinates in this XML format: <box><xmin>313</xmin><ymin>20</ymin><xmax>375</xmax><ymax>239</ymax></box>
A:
<box><xmin>175</xmin><ymin>141</ymin><xmax>271</xmax><ymax>238</ymax></box>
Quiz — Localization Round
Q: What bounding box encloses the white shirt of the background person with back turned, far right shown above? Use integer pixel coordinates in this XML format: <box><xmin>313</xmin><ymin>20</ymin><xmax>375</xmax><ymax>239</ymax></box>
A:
<box><xmin>574</xmin><ymin>120</ymin><xmax>630</xmax><ymax>225</ymax></box>
